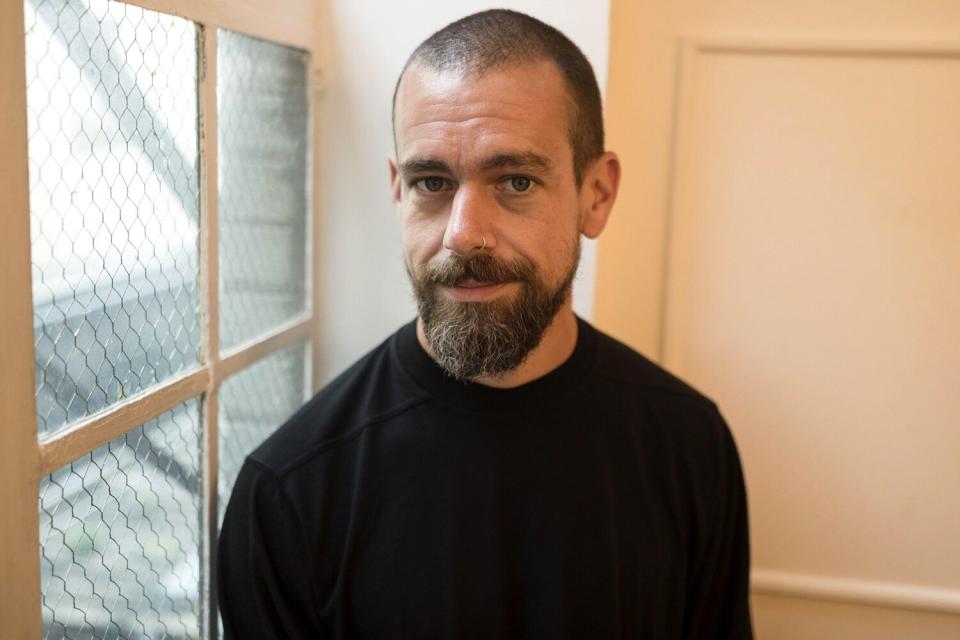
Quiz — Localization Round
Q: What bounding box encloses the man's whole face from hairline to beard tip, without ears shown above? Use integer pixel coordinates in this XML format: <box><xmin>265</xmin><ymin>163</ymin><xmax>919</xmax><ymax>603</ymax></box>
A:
<box><xmin>391</xmin><ymin>62</ymin><xmax>583</xmax><ymax>378</ymax></box>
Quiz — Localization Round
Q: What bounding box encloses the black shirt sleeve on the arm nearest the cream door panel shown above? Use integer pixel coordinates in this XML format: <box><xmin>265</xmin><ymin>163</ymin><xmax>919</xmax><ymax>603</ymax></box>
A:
<box><xmin>684</xmin><ymin>412</ymin><xmax>753</xmax><ymax>640</ymax></box>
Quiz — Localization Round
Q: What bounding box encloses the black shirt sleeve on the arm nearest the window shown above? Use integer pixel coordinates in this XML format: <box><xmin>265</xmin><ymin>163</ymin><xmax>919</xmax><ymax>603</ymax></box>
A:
<box><xmin>217</xmin><ymin>459</ymin><xmax>326</xmax><ymax>640</ymax></box>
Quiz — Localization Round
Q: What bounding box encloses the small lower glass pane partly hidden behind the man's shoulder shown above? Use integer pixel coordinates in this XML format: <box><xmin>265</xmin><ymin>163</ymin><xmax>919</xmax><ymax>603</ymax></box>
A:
<box><xmin>217</xmin><ymin>345</ymin><xmax>308</xmax><ymax>520</ymax></box>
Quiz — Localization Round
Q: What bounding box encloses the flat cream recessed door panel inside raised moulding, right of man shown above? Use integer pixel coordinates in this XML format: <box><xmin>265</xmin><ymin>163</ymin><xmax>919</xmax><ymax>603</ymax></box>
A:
<box><xmin>663</xmin><ymin>45</ymin><xmax>960</xmax><ymax>586</ymax></box>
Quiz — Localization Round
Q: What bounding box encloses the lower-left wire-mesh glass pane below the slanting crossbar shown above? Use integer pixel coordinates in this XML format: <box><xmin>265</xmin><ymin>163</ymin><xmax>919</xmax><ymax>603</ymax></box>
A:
<box><xmin>40</xmin><ymin>400</ymin><xmax>202</xmax><ymax>639</ymax></box>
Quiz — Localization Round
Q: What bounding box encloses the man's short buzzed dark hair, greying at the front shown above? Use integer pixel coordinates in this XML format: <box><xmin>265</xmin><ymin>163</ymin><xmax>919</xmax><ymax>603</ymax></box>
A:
<box><xmin>392</xmin><ymin>9</ymin><xmax>604</xmax><ymax>187</ymax></box>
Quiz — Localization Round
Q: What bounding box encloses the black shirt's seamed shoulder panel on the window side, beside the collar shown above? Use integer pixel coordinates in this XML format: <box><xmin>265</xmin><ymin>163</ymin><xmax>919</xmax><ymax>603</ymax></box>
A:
<box><xmin>249</xmin><ymin>324</ymin><xmax>424</xmax><ymax>478</ymax></box>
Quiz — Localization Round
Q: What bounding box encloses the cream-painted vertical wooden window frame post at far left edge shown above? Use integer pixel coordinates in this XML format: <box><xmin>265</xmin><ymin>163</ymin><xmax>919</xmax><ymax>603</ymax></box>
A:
<box><xmin>0</xmin><ymin>2</ymin><xmax>42</xmax><ymax>638</ymax></box>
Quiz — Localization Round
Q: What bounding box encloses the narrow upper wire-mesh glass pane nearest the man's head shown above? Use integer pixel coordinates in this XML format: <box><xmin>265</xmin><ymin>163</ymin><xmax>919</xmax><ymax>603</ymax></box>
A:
<box><xmin>217</xmin><ymin>31</ymin><xmax>310</xmax><ymax>348</ymax></box>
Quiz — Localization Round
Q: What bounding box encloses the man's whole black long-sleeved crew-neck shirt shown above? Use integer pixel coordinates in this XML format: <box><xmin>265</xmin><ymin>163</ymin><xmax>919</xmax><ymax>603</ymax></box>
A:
<box><xmin>218</xmin><ymin>319</ymin><xmax>752</xmax><ymax>640</ymax></box>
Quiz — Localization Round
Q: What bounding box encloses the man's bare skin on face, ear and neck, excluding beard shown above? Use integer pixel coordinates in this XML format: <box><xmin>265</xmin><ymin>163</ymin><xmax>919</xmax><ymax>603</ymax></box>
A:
<box><xmin>389</xmin><ymin>61</ymin><xmax>620</xmax><ymax>388</ymax></box>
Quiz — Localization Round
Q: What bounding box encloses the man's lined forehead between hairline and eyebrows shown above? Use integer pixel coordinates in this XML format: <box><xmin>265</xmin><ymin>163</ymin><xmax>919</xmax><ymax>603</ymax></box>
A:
<box><xmin>395</xmin><ymin>61</ymin><xmax>572</xmax><ymax>169</ymax></box>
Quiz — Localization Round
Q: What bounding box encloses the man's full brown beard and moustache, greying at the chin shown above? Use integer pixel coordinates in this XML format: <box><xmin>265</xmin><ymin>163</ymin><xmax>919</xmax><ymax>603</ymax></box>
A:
<box><xmin>408</xmin><ymin>238</ymin><xmax>580</xmax><ymax>380</ymax></box>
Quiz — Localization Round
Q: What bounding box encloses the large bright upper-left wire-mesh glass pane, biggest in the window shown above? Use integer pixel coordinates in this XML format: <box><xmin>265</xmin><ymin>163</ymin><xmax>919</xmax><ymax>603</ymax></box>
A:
<box><xmin>25</xmin><ymin>0</ymin><xmax>199</xmax><ymax>433</ymax></box>
